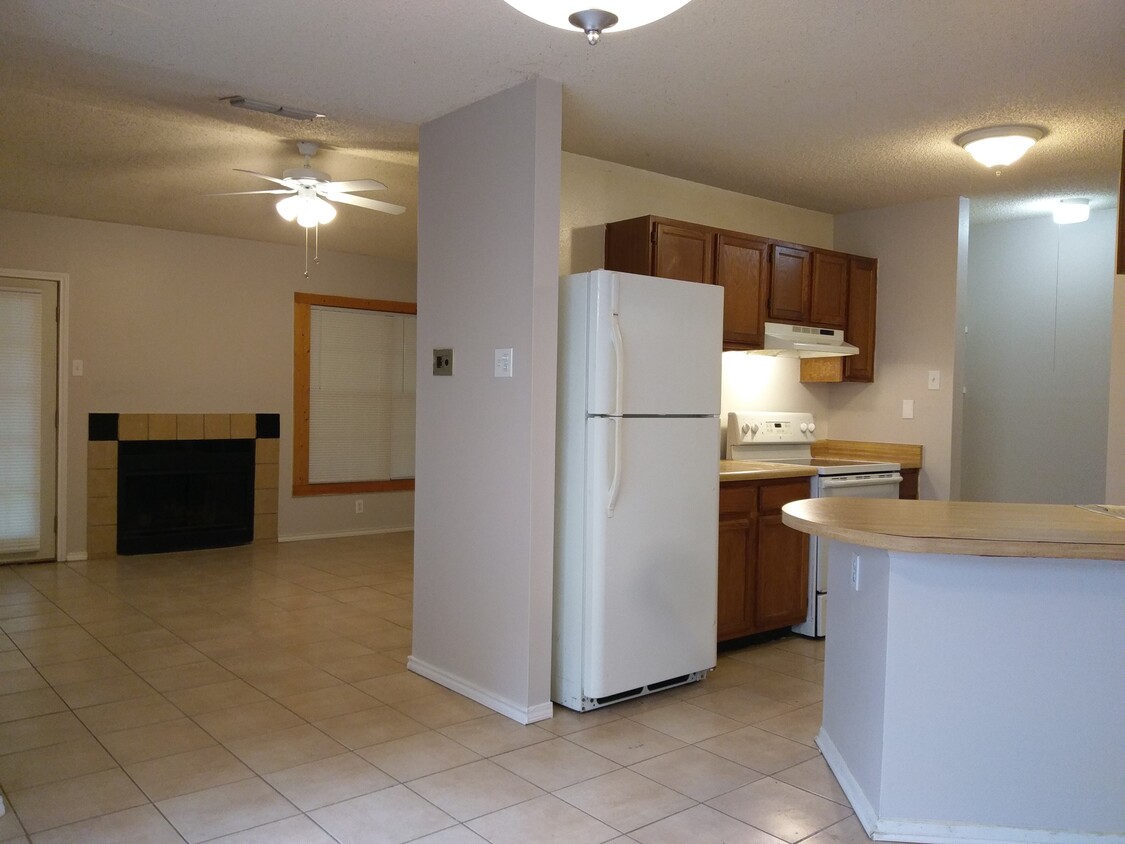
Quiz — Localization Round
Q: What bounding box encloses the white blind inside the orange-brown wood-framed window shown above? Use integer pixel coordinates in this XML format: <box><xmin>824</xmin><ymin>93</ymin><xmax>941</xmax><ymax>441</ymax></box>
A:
<box><xmin>308</xmin><ymin>305</ymin><xmax>416</xmax><ymax>484</ymax></box>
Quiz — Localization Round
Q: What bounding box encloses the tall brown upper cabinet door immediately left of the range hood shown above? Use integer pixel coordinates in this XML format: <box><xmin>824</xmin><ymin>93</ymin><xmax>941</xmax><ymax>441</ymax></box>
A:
<box><xmin>714</xmin><ymin>232</ymin><xmax>770</xmax><ymax>349</ymax></box>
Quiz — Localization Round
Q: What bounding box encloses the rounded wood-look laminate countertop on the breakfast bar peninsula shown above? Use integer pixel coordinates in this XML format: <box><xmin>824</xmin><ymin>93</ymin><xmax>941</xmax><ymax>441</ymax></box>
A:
<box><xmin>782</xmin><ymin>497</ymin><xmax>1125</xmax><ymax>560</ymax></box>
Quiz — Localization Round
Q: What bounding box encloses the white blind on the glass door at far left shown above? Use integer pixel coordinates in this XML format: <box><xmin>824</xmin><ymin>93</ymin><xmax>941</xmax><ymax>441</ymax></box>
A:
<box><xmin>0</xmin><ymin>289</ymin><xmax>43</xmax><ymax>554</ymax></box>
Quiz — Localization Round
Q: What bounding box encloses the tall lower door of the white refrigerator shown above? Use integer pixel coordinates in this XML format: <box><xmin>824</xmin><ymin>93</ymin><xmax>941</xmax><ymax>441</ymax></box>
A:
<box><xmin>583</xmin><ymin>417</ymin><xmax>719</xmax><ymax>698</ymax></box>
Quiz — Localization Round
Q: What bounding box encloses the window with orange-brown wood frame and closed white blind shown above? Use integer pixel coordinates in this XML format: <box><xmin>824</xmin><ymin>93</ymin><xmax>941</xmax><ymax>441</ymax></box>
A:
<box><xmin>294</xmin><ymin>294</ymin><xmax>416</xmax><ymax>495</ymax></box>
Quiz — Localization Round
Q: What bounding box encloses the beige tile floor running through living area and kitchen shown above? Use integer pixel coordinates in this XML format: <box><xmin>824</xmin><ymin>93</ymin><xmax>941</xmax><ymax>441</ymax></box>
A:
<box><xmin>0</xmin><ymin>533</ymin><xmax>867</xmax><ymax>844</ymax></box>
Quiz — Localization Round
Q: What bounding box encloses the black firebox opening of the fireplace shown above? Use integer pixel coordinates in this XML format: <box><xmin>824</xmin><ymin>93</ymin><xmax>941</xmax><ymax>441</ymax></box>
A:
<box><xmin>117</xmin><ymin>440</ymin><xmax>254</xmax><ymax>554</ymax></box>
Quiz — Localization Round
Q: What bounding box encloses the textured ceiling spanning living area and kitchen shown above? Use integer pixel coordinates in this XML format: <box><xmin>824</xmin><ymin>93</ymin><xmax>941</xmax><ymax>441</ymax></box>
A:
<box><xmin>0</xmin><ymin>0</ymin><xmax>1125</xmax><ymax>260</ymax></box>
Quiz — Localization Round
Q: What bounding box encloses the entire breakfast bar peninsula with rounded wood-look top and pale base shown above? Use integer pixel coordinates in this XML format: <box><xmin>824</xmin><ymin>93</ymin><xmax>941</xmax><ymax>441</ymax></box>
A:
<box><xmin>782</xmin><ymin>499</ymin><xmax>1125</xmax><ymax>844</ymax></box>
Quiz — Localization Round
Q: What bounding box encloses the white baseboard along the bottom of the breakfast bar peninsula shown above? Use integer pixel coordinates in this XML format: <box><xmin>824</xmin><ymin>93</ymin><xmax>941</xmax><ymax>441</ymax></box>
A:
<box><xmin>817</xmin><ymin>727</ymin><xmax>1125</xmax><ymax>844</ymax></box>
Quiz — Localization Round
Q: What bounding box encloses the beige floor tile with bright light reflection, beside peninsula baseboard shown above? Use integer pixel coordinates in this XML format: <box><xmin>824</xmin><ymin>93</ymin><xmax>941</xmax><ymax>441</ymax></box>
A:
<box><xmin>708</xmin><ymin>778</ymin><xmax>852</xmax><ymax>842</ymax></box>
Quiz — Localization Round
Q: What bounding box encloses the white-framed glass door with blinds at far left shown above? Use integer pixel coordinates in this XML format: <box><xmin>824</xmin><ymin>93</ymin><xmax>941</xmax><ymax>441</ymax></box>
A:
<box><xmin>0</xmin><ymin>277</ymin><xmax>59</xmax><ymax>563</ymax></box>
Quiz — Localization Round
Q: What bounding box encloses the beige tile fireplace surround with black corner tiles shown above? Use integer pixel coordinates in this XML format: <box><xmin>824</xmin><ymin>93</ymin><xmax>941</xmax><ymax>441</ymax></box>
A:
<box><xmin>86</xmin><ymin>413</ymin><xmax>280</xmax><ymax>559</ymax></box>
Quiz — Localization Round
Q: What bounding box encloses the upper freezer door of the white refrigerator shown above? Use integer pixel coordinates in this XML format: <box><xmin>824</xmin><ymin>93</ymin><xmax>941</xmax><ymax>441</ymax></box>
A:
<box><xmin>587</xmin><ymin>270</ymin><xmax>722</xmax><ymax>415</ymax></box>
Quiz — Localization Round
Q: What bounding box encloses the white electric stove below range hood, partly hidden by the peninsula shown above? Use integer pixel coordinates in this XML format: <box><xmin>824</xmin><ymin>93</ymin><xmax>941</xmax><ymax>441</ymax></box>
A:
<box><xmin>727</xmin><ymin>411</ymin><xmax>902</xmax><ymax>637</ymax></box>
